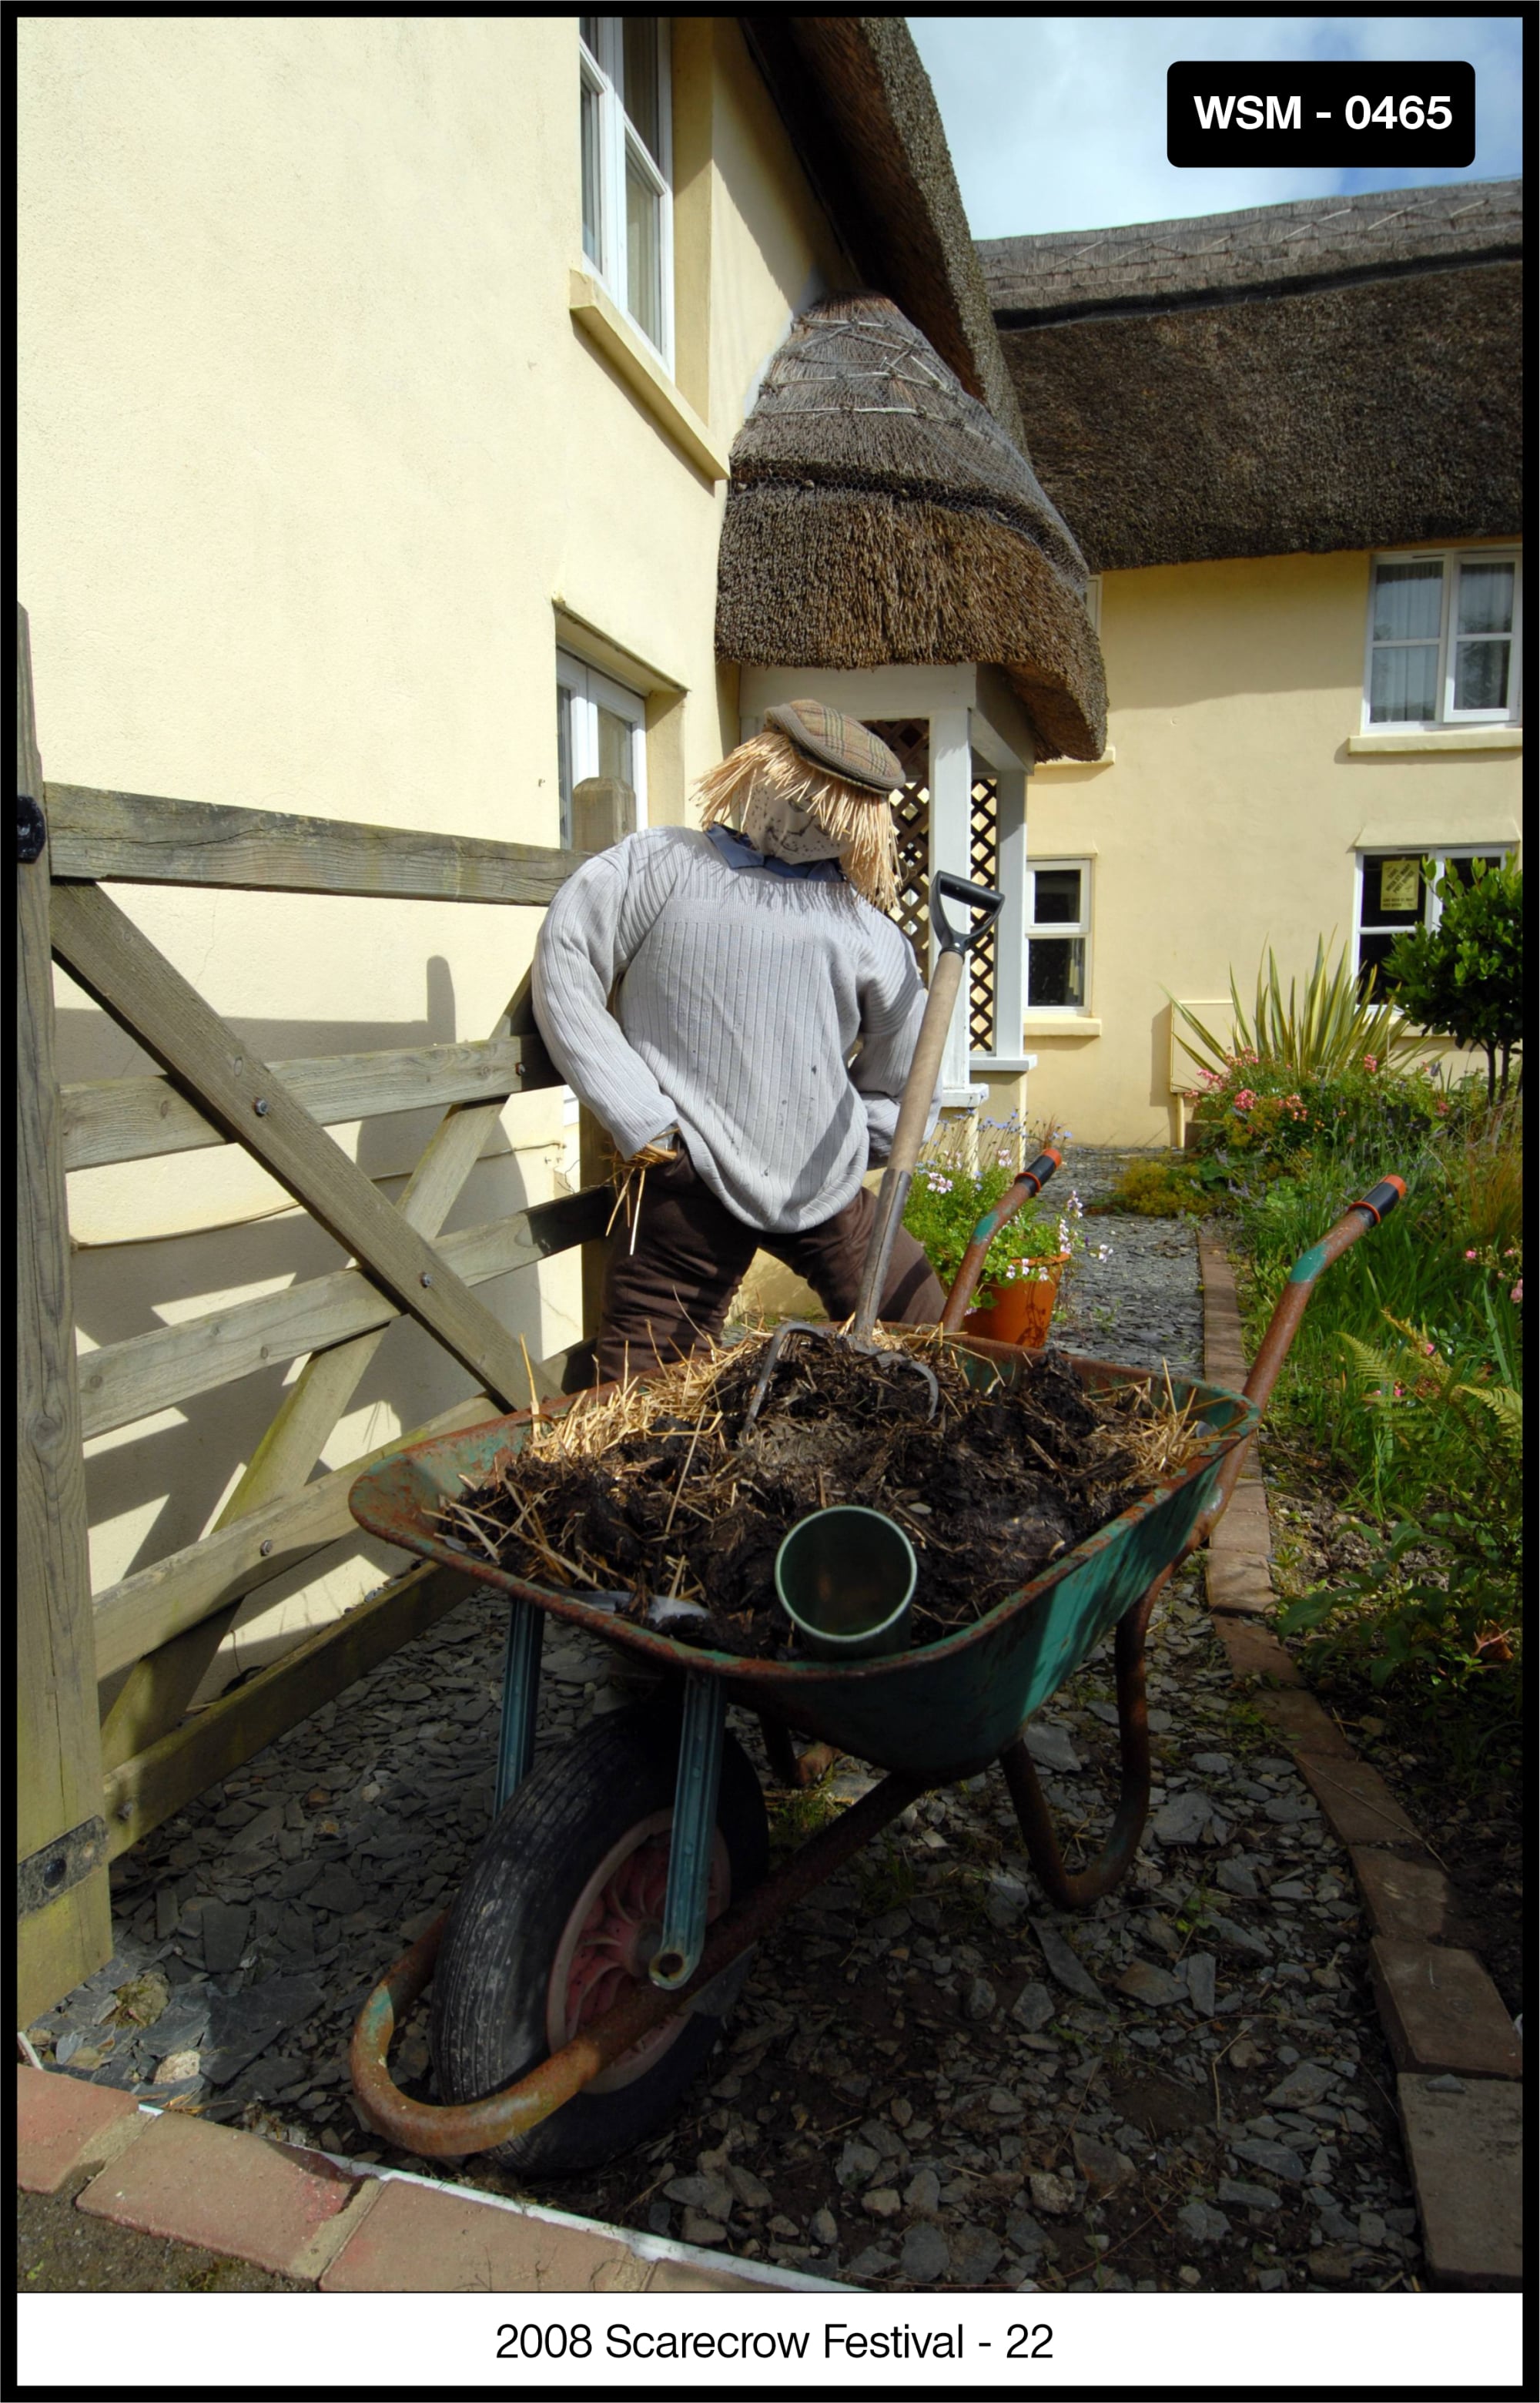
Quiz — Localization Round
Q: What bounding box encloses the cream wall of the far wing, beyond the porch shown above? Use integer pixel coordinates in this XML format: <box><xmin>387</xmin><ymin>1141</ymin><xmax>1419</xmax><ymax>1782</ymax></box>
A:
<box><xmin>1023</xmin><ymin>550</ymin><xmax>1521</xmax><ymax>1144</ymax></box>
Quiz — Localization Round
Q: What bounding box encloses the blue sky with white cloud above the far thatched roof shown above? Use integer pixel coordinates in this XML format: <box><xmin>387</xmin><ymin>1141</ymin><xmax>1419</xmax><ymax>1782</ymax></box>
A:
<box><xmin>908</xmin><ymin>15</ymin><xmax>1523</xmax><ymax>243</ymax></box>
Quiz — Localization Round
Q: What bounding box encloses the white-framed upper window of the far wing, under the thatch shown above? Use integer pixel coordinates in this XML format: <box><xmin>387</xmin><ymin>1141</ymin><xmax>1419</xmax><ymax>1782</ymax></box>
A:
<box><xmin>1364</xmin><ymin>550</ymin><xmax>1521</xmax><ymax>726</ymax></box>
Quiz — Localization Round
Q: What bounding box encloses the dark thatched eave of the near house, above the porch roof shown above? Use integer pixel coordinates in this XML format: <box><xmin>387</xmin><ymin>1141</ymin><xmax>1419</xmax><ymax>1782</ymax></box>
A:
<box><xmin>738</xmin><ymin>9</ymin><xmax>1026</xmax><ymax>447</ymax></box>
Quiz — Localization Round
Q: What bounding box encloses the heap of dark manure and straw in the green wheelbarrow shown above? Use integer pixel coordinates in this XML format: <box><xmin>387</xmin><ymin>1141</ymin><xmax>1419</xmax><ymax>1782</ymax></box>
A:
<box><xmin>440</xmin><ymin>1329</ymin><xmax>1206</xmax><ymax>1661</ymax></box>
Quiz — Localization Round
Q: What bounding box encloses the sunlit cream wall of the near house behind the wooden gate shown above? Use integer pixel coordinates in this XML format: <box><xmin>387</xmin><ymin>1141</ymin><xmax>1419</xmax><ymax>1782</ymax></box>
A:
<box><xmin>19</xmin><ymin>15</ymin><xmax>843</xmax><ymax>1675</ymax></box>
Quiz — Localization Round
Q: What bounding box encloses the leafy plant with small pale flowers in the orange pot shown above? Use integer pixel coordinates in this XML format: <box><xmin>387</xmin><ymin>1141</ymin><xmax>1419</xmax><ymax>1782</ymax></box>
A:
<box><xmin>903</xmin><ymin>1118</ymin><xmax>1113</xmax><ymax>1309</ymax></box>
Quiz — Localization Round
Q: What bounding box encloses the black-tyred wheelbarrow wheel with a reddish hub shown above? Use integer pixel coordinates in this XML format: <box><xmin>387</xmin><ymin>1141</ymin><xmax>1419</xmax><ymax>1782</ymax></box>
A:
<box><xmin>430</xmin><ymin>1701</ymin><xmax>768</xmax><ymax>2170</ymax></box>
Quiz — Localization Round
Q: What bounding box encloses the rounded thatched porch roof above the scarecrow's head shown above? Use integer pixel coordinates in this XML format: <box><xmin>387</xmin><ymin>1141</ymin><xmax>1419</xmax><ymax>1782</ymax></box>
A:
<box><xmin>716</xmin><ymin>293</ymin><xmax>1105</xmax><ymax>759</ymax></box>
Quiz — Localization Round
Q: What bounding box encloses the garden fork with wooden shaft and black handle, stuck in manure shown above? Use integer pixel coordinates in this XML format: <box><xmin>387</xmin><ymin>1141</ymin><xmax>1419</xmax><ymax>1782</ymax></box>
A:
<box><xmin>742</xmin><ymin>875</ymin><xmax>1004</xmax><ymax>1435</ymax></box>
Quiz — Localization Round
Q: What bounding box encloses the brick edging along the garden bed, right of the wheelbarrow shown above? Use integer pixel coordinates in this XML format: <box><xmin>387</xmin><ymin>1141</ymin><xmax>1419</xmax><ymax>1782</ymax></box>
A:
<box><xmin>1199</xmin><ymin>1235</ymin><xmax>1523</xmax><ymax>2287</ymax></box>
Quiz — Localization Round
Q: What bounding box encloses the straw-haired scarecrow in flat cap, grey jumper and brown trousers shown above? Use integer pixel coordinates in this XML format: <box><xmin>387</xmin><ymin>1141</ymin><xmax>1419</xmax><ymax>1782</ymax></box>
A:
<box><xmin>534</xmin><ymin>702</ymin><xmax>944</xmax><ymax>1382</ymax></box>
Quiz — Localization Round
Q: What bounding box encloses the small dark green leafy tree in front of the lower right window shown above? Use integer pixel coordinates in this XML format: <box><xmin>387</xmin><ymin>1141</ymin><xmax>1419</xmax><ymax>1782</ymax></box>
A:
<box><xmin>1381</xmin><ymin>860</ymin><xmax>1523</xmax><ymax>1103</ymax></box>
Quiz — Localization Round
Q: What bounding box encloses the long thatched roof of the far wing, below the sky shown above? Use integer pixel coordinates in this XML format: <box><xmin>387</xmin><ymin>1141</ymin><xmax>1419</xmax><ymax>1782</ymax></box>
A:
<box><xmin>980</xmin><ymin>180</ymin><xmax>1525</xmax><ymax>569</ymax></box>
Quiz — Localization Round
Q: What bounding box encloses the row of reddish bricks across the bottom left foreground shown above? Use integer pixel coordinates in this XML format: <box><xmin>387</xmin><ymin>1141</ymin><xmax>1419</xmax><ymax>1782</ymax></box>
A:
<box><xmin>17</xmin><ymin>2062</ymin><xmax>843</xmax><ymax>2295</ymax></box>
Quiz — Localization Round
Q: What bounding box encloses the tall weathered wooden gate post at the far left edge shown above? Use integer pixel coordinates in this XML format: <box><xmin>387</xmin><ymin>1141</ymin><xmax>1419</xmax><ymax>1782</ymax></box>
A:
<box><xmin>15</xmin><ymin>610</ymin><xmax>113</xmax><ymax>2028</ymax></box>
